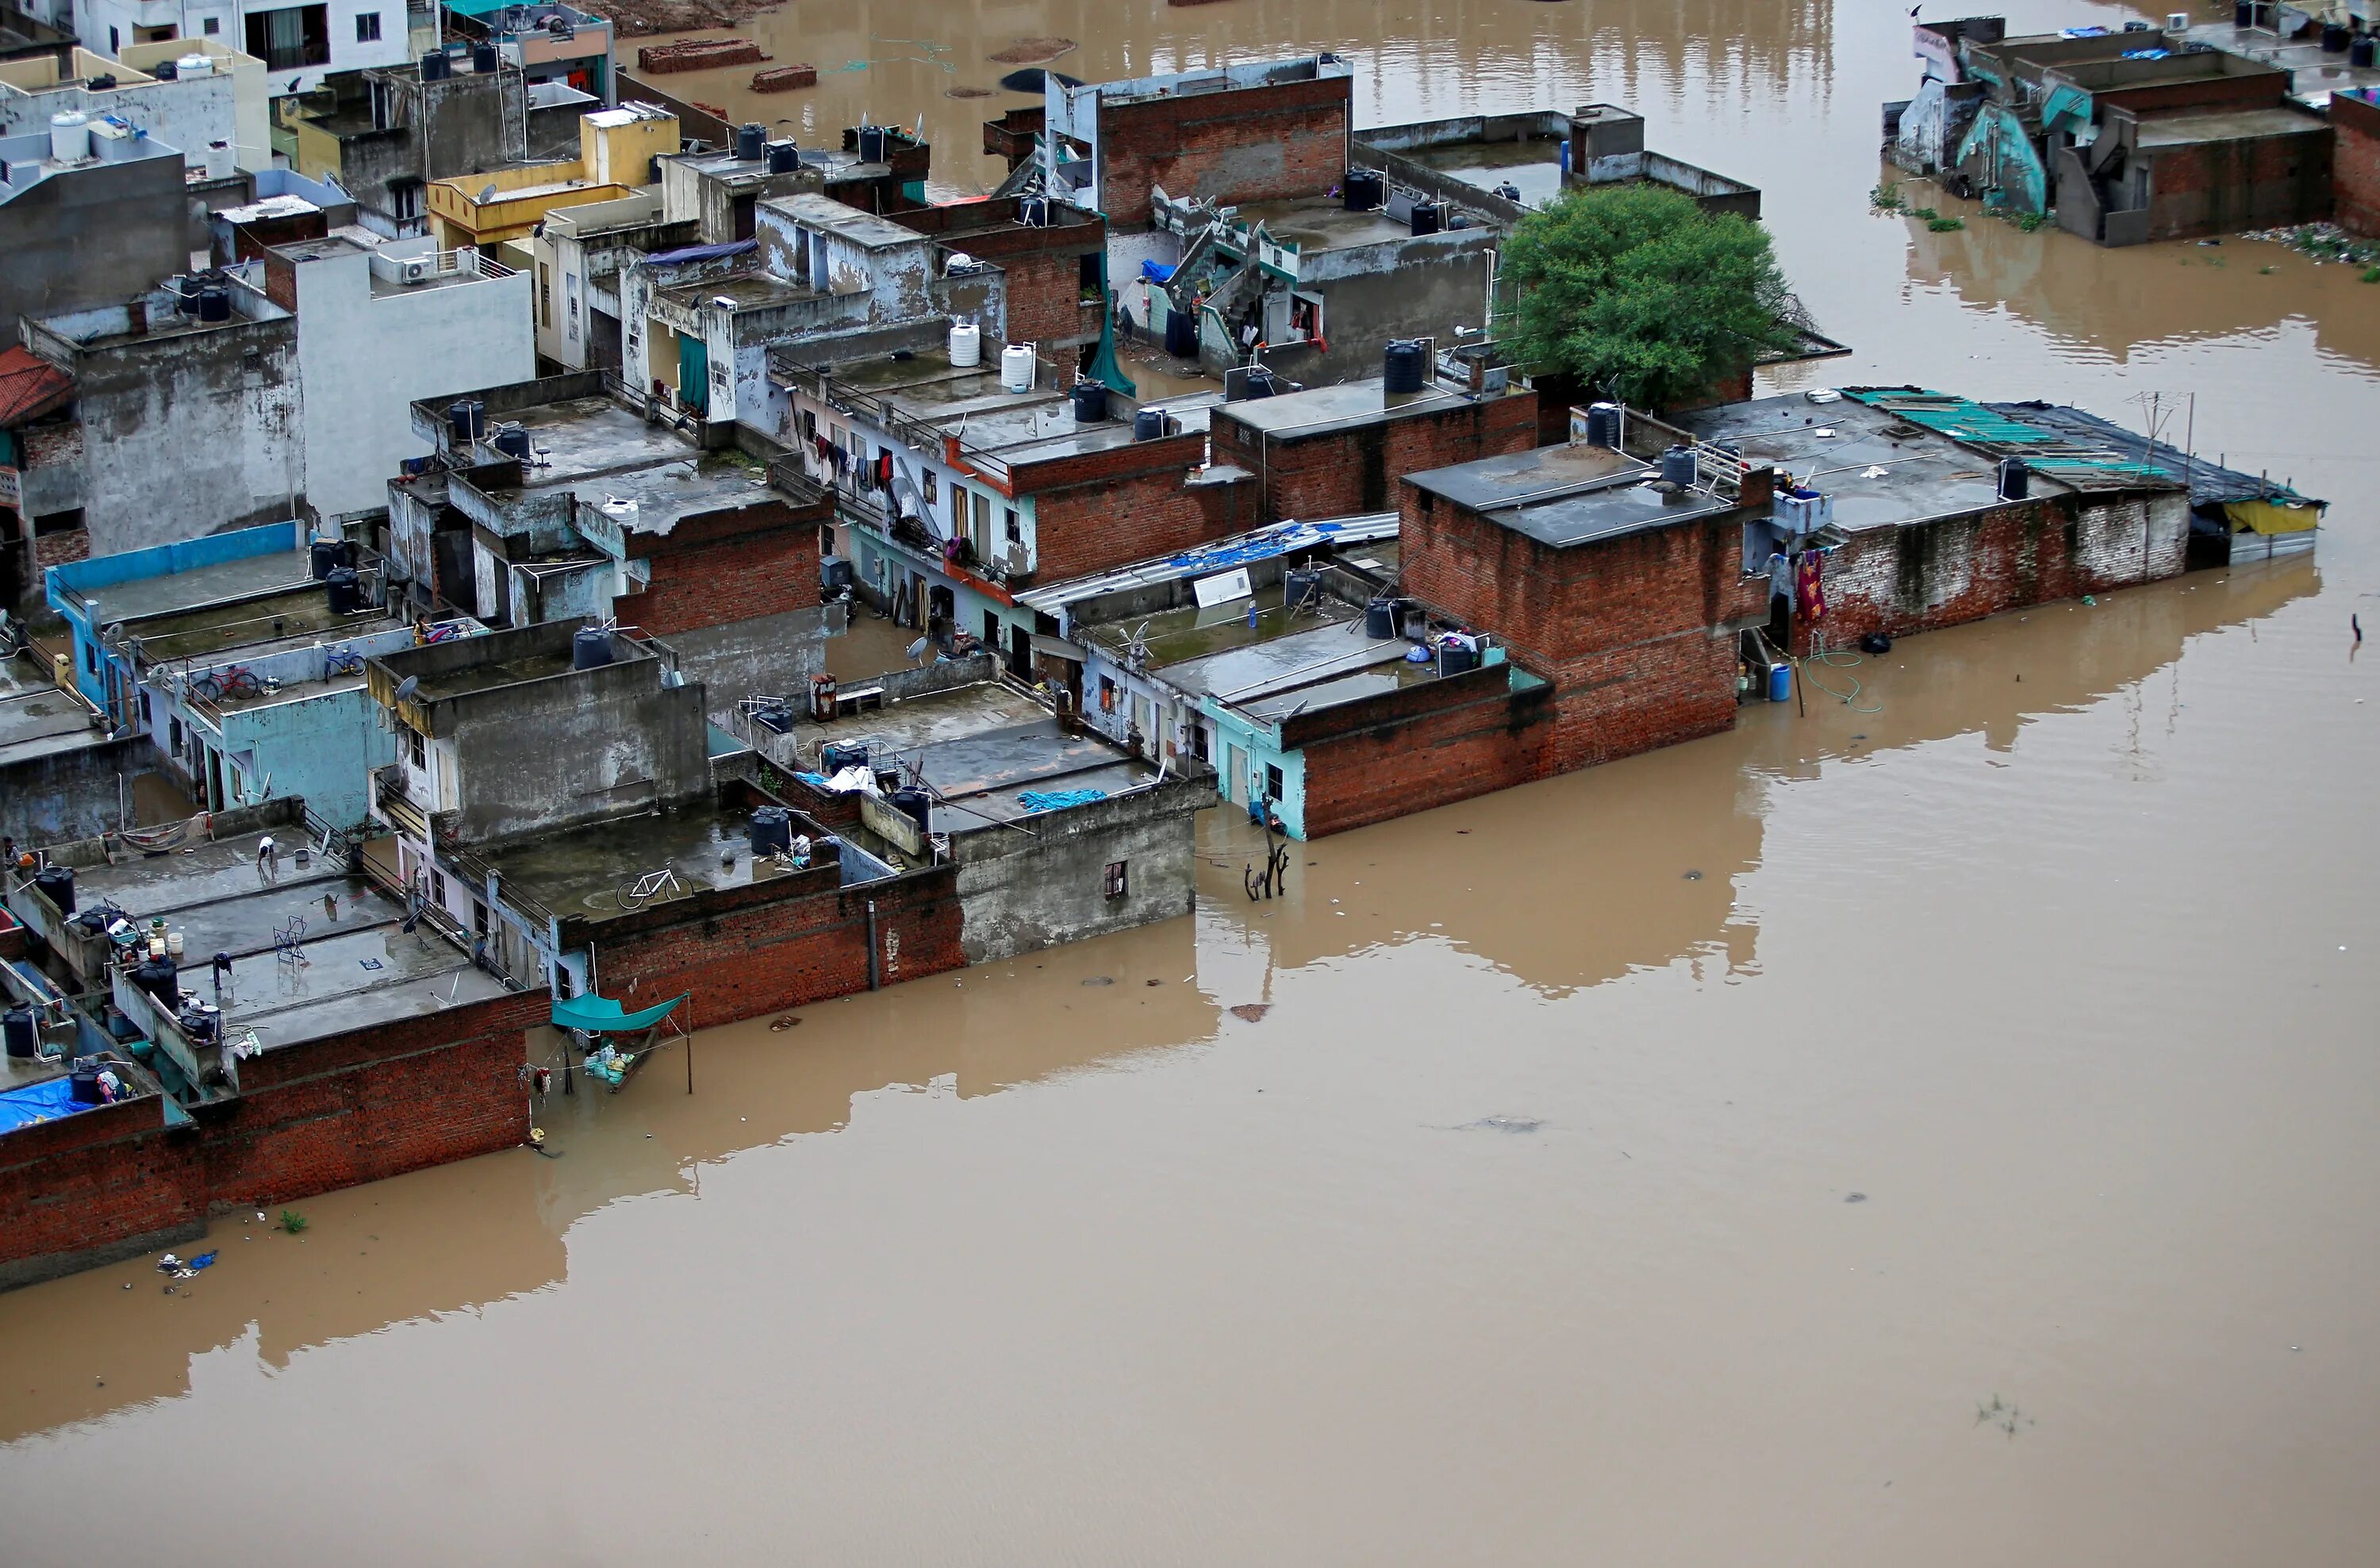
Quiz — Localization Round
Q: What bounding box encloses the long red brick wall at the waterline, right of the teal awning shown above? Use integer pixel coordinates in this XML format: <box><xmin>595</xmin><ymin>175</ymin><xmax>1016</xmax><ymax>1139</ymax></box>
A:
<box><xmin>581</xmin><ymin>866</ymin><xmax>966</xmax><ymax>1028</ymax></box>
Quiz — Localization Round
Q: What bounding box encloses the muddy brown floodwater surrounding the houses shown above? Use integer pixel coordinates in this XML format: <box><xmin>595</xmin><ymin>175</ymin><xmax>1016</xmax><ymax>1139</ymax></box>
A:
<box><xmin>0</xmin><ymin>0</ymin><xmax>2380</xmax><ymax>1568</ymax></box>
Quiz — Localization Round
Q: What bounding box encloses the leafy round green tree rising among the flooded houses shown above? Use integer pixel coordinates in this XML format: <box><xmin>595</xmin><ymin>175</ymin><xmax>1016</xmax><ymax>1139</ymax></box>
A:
<box><xmin>1504</xmin><ymin>186</ymin><xmax>1797</xmax><ymax>407</ymax></box>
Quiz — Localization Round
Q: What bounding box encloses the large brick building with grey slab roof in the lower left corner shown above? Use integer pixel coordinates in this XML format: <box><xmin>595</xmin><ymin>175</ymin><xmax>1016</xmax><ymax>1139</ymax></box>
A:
<box><xmin>0</xmin><ymin>801</ymin><xmax>545</xmax><ymax>1287</ymax></box>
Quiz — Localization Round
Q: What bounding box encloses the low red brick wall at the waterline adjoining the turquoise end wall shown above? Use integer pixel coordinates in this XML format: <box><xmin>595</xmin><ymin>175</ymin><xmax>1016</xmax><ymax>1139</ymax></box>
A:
<box><xmin>1283</xmin><ymin>669</ymin><xmax>1554</xmax><ymax>840</ymax></box>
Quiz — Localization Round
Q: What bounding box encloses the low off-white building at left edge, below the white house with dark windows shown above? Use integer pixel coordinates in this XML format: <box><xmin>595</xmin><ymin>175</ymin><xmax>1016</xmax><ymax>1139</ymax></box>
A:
<box><xmin>0</xmin><ymin>40</ymin><xmax>274</xmax><ymax>169</ymax></box>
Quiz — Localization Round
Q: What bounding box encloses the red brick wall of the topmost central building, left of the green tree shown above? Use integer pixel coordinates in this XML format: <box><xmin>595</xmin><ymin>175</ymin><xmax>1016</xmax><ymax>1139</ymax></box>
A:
<box><xmin>1100</xmin><ymin>76</ymin><xmax>1349</xmax><ymax>226</ymax></box>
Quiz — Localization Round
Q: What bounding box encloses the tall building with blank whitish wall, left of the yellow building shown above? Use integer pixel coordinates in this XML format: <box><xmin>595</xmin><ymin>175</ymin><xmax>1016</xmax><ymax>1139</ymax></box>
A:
<box><xmin>255</xmin><ymin>214</ymin><xmax>538</xmax><ymax>519</ymax></box>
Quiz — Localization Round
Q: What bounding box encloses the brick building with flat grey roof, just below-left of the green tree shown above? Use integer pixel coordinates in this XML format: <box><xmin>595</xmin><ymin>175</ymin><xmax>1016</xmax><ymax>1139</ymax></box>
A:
<box><xmin>1209</xmin><ymin>376</ymin><xmax>1537</xmax><ymax>524</ymax></box>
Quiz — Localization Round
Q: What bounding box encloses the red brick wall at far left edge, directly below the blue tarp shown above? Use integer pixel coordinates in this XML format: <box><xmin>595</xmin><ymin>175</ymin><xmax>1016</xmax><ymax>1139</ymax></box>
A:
<box><xmin>0</xmin><ymin>1099</ymin><xmax>207</xmax><ymax>1287</ymax></box>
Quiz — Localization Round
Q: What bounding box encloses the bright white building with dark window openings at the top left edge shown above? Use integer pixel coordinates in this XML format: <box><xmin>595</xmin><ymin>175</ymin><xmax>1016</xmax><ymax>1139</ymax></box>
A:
<box><xmin>74</xmin><ymin>0</ymin><xmax>412</xmax><ymax>98</ymax></box>
